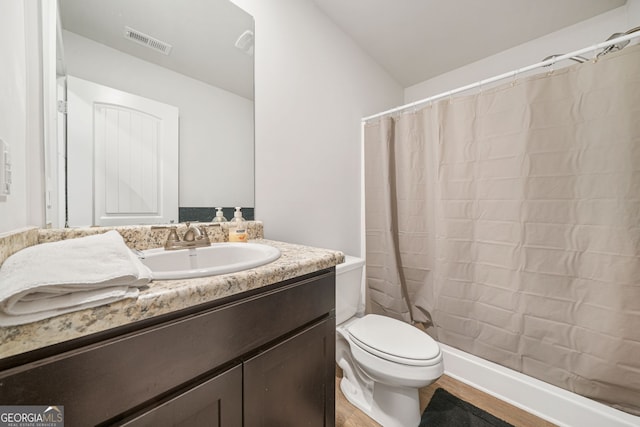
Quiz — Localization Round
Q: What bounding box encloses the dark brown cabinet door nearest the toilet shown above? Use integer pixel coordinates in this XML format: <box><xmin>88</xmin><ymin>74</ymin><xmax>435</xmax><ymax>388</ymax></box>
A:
<box><xmin>244</xmin><ymin>317</ymin><xmax>335</xmax><ymax>427</ymax></box>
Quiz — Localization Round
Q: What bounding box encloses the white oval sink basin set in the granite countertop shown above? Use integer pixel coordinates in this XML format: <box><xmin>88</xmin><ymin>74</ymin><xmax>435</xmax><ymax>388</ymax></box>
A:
<box><xmin>140</xmin><ymin>243</ymin><xmax>280</xmax><ymax>280</ymax></box>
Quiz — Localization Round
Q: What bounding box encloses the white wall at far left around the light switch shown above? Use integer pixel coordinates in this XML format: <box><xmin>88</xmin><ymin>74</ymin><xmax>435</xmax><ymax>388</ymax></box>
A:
<box><xmin>0</xmin><ymin>0</ymin><xmax>44</xmax><ymax>233</ymax></box>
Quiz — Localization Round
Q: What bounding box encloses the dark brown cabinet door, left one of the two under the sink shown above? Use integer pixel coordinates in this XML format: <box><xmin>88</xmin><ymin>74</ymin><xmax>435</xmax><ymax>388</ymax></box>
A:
<box><xmin>118</xmin><ymin>365</ymin><xmax>242</xmax><ymax>427</ymax></box>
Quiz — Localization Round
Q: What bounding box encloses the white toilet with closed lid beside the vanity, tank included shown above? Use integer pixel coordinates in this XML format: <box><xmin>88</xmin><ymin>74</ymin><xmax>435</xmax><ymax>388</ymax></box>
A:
<box><xmin>336</xmin><ymin>256</ymin><xmax>444</xmax><ymax>427</ymax></box>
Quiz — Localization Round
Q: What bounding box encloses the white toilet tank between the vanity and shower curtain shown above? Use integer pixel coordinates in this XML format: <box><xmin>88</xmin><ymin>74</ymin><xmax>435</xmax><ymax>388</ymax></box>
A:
<box><xmin>336</xmin><ymin>255</ymin><xmax>364</xmax><ymax>325</ymax></box>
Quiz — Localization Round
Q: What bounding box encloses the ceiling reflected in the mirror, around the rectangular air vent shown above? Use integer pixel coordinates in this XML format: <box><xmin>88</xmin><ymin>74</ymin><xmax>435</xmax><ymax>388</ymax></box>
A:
<box><xmin>59</xmin><ymin>0</ymin><xmax>254</xmax><ymax>99</ymax></box>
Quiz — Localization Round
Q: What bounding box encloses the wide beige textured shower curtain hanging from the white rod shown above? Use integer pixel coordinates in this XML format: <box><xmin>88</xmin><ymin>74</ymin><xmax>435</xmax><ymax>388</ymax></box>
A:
<box><xmin>365</xmin><ymin>46</ymin><xmax>640</xmax><ymax>415</ymax></box>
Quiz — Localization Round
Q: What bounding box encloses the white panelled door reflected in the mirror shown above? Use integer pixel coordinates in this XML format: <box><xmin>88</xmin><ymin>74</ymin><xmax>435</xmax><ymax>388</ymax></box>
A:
<box><xmin>67</xmin><ymin>76</ymin><xmax>178</xmax><ymax>227</ymax></box>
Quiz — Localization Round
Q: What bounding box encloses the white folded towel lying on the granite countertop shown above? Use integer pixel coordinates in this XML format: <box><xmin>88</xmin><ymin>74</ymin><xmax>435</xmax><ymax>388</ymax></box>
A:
<box><xmin>0</xmin><ymin>231</ymin><xmax>151</xmax><ymax>326</ymax></box>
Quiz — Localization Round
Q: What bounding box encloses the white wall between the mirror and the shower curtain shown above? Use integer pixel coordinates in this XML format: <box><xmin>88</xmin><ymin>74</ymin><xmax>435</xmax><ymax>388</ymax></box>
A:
<box><xmin>233</xmin><ymin>0</ymin><xmax>402</xmax><ymax>255</ymax></box>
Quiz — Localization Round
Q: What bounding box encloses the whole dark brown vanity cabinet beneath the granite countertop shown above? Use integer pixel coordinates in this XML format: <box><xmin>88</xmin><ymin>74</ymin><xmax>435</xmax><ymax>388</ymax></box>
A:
<box><xmin>0</xmin><ymin>269</ymin><xmax>335</xmax><ymax>427</ymax></box>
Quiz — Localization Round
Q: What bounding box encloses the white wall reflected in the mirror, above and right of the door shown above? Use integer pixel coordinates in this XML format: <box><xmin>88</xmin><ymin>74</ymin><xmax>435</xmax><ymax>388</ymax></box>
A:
<box><xmin>63</xmin><ymin>31</ymin><xmax>254</xmax><ymax>207</ymax></box>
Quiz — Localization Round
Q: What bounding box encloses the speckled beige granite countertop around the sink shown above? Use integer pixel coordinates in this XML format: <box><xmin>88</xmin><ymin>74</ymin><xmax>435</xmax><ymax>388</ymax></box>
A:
<box><xmin>0</xmin><ymin>239</ymin><xmax>344</xmax><ymax>359</ymax></box>
